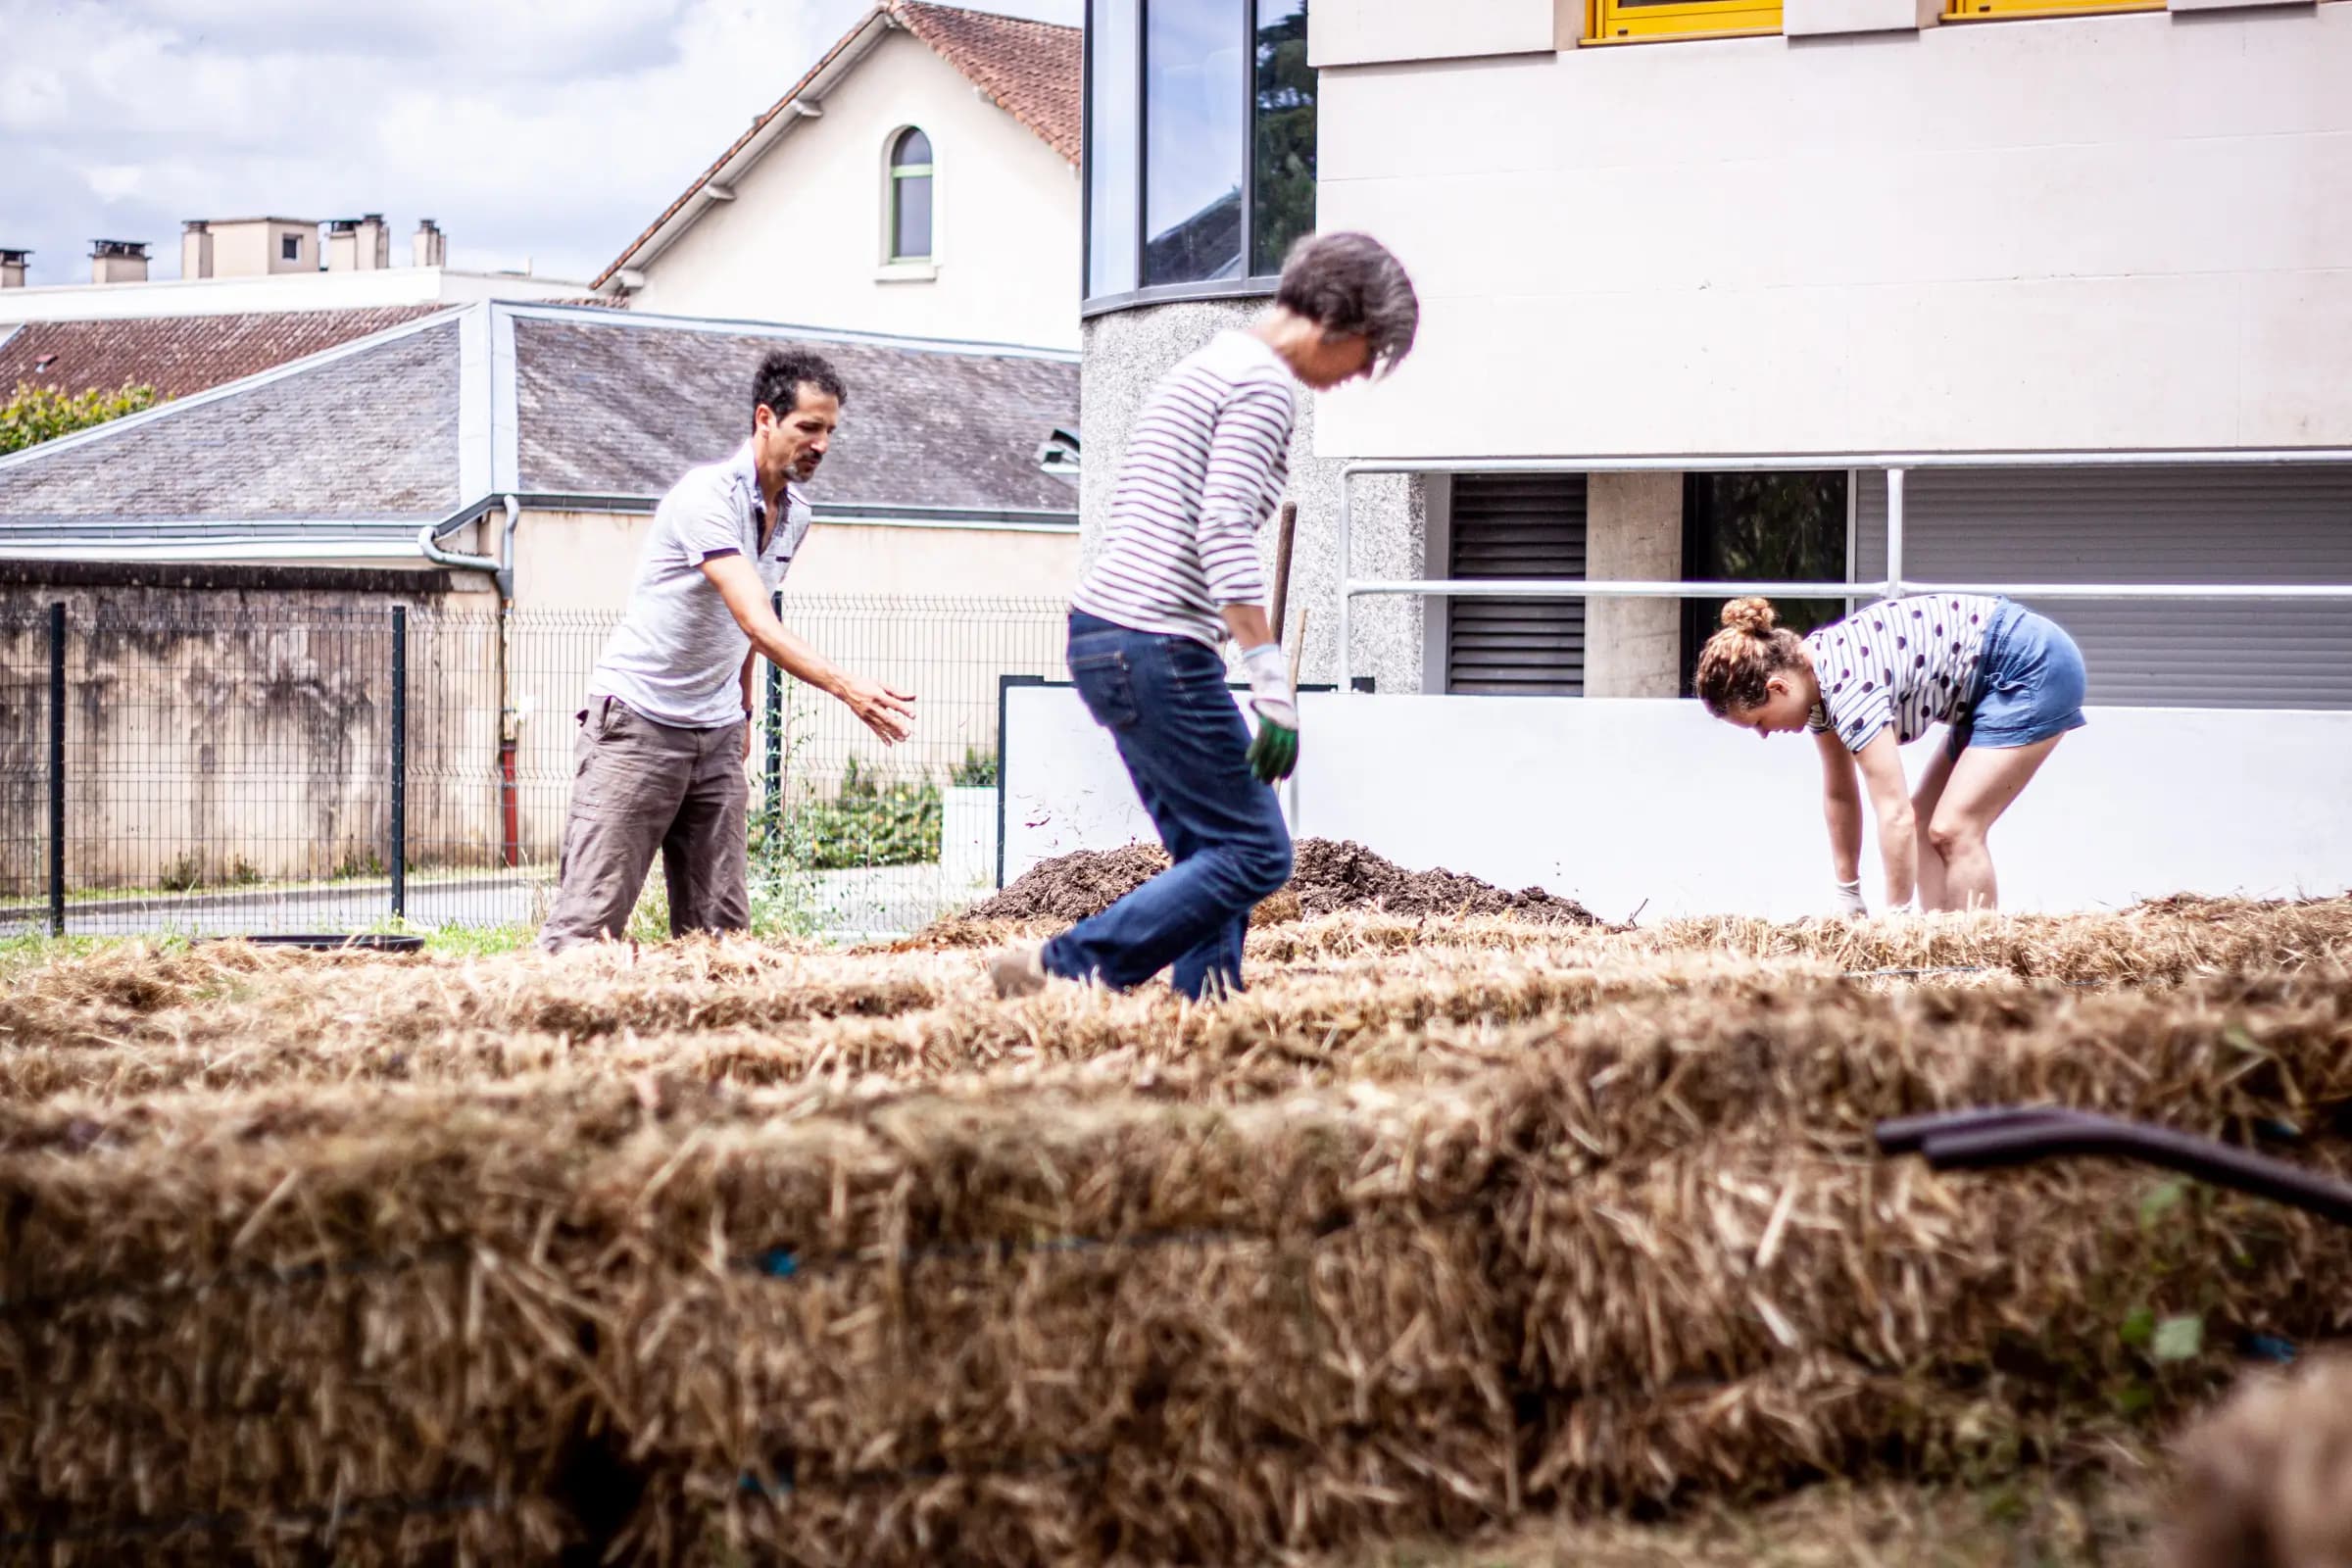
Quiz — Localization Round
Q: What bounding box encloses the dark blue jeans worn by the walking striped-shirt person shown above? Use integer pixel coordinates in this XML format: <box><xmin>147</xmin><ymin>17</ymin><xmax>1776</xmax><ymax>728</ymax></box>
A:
<box><xmin>1045</xmin><ymin>612</ymin><xmax>1292</xmax><ymax>997</ymax></box>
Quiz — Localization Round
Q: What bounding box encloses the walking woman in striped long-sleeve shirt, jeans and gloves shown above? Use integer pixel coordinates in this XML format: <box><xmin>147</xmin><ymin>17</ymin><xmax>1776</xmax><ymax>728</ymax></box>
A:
<box><xmin>990</xmin><ymin>232</ymin><xmax>1421</xmax><ymax>997</ymax></box>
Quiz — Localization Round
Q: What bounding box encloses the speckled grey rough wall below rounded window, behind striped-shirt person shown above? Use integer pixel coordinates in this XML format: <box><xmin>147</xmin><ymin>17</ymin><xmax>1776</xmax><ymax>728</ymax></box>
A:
<box><xmin>1080</xmin><ymin>301</ymin><xmax>1425</xmax><ymax>691</ymax></box>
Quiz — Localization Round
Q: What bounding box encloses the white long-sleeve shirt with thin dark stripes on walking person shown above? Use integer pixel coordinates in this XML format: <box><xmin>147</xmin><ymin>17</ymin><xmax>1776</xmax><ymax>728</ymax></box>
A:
<box><xmin>1070</xmin><ymin>331</ymin><xmax>1298</xmax><ymax>649</ymax></box>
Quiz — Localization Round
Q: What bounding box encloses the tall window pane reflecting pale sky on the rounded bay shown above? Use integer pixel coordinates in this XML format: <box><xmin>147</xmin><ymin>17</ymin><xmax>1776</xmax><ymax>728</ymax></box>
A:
<box><xmin>1143</xmin><ymin>0</ymin><xmax>1245</xmax><ymax>284</ymax></box>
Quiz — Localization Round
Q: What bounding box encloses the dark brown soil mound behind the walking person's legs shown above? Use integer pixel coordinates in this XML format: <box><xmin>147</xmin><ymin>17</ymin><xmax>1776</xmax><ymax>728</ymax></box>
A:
<box><xmin>962</xmin><ymin>839</ymin><xmax>1601</xmax><ymax>926</ymax></box>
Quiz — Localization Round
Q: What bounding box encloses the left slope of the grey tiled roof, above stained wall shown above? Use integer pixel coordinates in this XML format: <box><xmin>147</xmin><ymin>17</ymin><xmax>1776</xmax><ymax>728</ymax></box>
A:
<box><xmin>0</xmin><ymin>319</ymin><xmax>459</xmax><ymax>534</ymax></box>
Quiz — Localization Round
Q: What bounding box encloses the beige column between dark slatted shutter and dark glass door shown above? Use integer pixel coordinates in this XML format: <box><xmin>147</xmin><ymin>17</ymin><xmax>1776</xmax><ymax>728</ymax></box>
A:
<box><xmin>1586</xmin><ymin>472</ymin><xmax>1682</xmax><ymax>696</ymax></box>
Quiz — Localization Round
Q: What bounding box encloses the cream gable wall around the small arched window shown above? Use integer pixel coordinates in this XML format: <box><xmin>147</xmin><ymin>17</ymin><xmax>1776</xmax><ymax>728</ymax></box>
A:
<box><xmin>630</xmin><ymin>30</ymin><xmax>1080</xmax><ymax>348</ymax></box>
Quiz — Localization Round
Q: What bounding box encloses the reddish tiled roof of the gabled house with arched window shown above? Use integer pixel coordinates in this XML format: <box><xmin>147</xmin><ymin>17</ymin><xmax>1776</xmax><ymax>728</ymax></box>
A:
<box><xmin>590</xmin><ymin>0</ymin><xmax>1084</xmax><ymax>287</ymax></box>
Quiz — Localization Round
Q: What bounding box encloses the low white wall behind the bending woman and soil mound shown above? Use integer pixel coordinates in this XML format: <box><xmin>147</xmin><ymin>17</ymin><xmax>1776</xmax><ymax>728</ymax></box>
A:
<box><xmin>1004</xmin><ymin>686</ymin><xmax>2352</xmax><ymax>921</ymax></box>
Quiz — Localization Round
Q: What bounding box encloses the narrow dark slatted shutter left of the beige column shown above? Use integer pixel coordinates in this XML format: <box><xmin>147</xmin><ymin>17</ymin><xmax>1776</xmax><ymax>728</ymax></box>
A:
<box><xmin>1446</xmin><ymin>475</ymin><xmax>1586</xmax><ymax>696</ymax></box>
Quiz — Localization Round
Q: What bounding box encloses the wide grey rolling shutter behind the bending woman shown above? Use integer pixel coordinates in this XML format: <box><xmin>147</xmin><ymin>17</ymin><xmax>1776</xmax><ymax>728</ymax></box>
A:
<box><xmin>1853</xmin><ymin>466</ymin><xmax>2352</xmax><ymax>708</ymax></box>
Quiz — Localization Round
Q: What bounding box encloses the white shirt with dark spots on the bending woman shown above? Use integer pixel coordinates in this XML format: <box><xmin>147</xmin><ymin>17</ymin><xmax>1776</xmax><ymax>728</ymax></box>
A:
<box><xmin>1804</xmin><ymin>592</ymin><xmax>2001</xmax><ymax>753</ymax></box>
